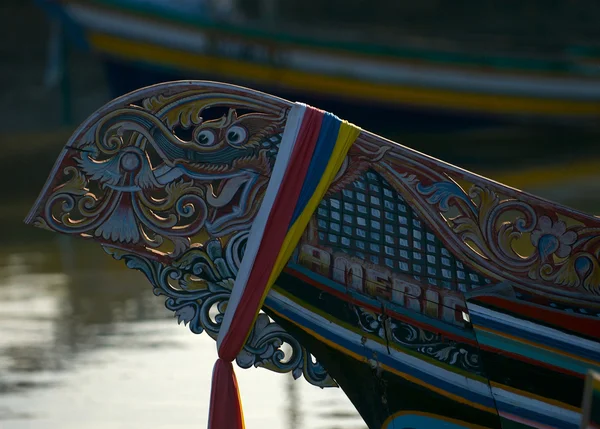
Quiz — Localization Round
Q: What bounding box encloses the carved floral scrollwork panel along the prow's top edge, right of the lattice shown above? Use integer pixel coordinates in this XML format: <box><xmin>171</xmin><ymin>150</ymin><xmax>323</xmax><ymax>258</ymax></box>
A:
<box><xmin>332</xmin><ymin>138</ymin><xmax>600</xmax><ymax>299</ymax></box>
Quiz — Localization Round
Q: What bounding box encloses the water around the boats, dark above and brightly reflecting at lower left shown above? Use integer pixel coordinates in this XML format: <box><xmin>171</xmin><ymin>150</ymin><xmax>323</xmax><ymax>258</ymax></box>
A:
<box><xmin>0</xmin><ymin>0</ymin><xmax>600</xmax><ymax>429</ymax></box>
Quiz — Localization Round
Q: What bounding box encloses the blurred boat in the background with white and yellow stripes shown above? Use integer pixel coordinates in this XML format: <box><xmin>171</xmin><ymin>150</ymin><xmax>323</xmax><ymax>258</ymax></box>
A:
<box><xmin>38</xmin><ymin>0</ymin><xmax>600</xmax><ymax>130</ymax></box>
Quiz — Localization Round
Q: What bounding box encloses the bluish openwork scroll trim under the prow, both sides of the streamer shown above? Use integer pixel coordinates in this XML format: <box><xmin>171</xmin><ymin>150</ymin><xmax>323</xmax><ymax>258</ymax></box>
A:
<box><xmin>105</xmin><ymin>232</ymin><xmax>337</xmax><ymax>387</ymax></box>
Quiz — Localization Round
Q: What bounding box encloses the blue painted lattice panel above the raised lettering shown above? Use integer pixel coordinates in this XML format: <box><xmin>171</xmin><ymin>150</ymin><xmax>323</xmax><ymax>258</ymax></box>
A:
<box><xmin>317</xmin><ymin>171</ymin><xmax>490</xmax><ymax>292</ymax></box>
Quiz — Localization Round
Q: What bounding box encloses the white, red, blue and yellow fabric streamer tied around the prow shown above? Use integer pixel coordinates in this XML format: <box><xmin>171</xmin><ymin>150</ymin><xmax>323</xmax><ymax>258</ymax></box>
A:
<box><xmin>208</xmin><ymin>103</ymin><xmax>360</xmax><ymax>429</ymax></box>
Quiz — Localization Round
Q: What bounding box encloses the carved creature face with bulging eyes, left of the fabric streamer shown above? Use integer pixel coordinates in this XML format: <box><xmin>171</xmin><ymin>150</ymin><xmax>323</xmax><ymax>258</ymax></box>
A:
<box><xmin>35</xmin><ymin>85</ymin><xmax>286</xmax><ymax>257</ymax></box>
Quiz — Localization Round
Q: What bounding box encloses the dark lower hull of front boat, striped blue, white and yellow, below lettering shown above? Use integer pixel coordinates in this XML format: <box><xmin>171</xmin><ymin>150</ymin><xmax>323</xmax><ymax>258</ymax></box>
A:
<box><xmin>265</xmin><ymin>267</ymin><xmax>585</xmax><ymax>429</ymax></box>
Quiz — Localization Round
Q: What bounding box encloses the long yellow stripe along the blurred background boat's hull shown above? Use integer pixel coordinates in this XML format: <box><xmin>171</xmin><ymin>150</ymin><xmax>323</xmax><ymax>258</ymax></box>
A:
<box><xmin>89</xmin><ymin>32</ymin><xmax>600</xmax><ymax>117</ymax></box>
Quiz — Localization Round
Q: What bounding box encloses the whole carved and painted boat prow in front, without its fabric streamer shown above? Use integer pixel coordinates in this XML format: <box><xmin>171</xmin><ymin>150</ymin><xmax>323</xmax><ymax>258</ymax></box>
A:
<box><xmin>26</xmin><ymin>82</ymin><xmax>600</xmax><ymax>429</ymax></box>
